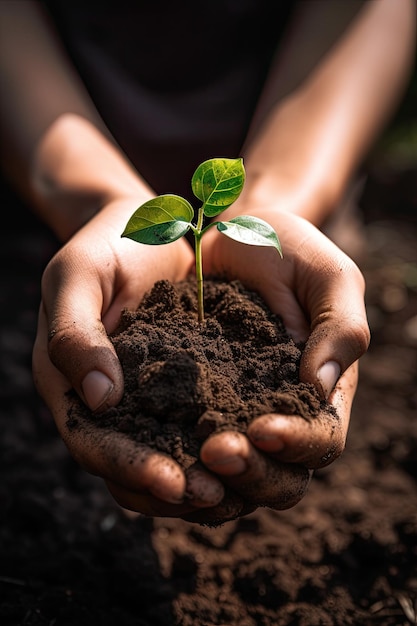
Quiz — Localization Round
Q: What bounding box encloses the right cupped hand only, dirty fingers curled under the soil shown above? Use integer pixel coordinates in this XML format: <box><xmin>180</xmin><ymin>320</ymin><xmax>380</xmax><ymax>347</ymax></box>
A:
<box><xmin>193</xmin><ymin>209</ymin><xmax>369</xmax><ymax>509</ymax></box>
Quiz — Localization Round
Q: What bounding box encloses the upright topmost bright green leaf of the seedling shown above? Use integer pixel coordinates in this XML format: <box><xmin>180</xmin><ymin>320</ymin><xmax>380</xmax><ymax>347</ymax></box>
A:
<box><xmin>191</xmin><ymin>158</ymin><xmax>245</xmax><ymax>217</ymax></box>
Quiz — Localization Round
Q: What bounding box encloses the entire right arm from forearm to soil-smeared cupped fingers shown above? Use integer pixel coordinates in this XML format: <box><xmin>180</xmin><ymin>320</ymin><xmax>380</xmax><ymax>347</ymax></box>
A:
<box><xmin>197</xmin><ymin>0</ymin><xmax>416</xmax><ymax>508</ymax></box>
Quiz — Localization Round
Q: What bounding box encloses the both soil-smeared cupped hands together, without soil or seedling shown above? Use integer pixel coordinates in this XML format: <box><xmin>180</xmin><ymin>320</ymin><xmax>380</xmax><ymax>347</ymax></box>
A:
<box><xmin>33</xmin><ymin>200</ymin><xmax>367</xmax><ymax>523</ymax></box>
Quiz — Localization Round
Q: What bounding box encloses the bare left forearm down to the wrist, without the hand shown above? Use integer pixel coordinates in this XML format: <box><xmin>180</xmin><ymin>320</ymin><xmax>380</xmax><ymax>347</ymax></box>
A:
<box><xmin>0</xmin><ymin>0</ymin><xmax>152</xmax><ymax>241</ymax></box>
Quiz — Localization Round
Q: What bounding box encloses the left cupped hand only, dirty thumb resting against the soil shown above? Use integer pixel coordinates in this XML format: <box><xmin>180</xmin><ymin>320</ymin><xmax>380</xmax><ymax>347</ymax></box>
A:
<box><xmin>33</xmin><ymin>198</ymin><xmax>237</xmax><ymax>516</ymax></box>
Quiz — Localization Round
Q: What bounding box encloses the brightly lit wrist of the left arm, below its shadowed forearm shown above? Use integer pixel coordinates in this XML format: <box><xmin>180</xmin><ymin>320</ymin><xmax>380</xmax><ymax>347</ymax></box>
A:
<box><xmin>29</xmin><ymin>115</ymin><xmax>154</xmax><ymax>242</ymax></box>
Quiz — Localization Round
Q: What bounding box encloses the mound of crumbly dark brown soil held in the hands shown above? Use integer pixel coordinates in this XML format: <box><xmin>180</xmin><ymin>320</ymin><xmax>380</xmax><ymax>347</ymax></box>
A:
<box><xmin>68</xmin><ymin>278</ymin><xmax>337</xmax><ymax>526</ymax></box>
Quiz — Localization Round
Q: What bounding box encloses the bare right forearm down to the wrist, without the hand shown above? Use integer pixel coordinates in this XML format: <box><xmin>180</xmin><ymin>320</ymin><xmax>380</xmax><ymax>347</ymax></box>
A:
<box><xmin>242</xmin><ymin>0</ymin><xmax>416</xmax><ymax>225</ymax></box>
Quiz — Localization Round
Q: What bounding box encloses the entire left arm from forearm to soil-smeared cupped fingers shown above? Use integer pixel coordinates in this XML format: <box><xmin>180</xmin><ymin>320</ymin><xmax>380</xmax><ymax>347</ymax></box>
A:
<box><xmin>0</xmin><ymin>0</ymin><xmax>223</xmax><ymax>515</ymax></box>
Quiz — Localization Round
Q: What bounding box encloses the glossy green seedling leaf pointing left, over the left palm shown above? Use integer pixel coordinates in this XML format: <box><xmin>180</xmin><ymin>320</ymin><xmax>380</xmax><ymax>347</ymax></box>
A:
<box><xmin>122</xmin><ymin>194</ymin><xmax>194</xmax><ymax>245</ymax></box>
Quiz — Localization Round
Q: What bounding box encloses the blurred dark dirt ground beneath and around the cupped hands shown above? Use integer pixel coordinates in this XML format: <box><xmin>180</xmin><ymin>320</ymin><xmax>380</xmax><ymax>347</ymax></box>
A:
<box><xmin>0</xmin><ymin>157</ymin><xmax>417</xmax><ymax>626</ymax></box>
